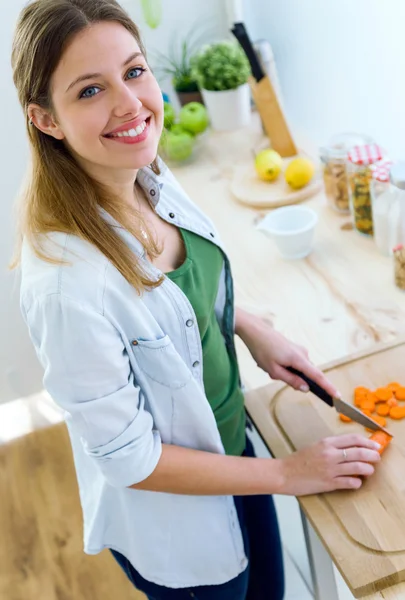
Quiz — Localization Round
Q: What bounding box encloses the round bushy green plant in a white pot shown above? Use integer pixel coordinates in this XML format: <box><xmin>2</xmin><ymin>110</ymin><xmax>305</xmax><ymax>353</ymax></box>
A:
<box><xmin>191</xmin><ymin>41</ymin><xmax>251</xmax><ymax>131</ymax></box>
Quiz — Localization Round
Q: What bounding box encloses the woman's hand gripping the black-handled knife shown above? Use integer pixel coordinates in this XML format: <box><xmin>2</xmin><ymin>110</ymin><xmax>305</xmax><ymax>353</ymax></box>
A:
<box><xmin>236</xmin><ymin>309</ymin><xmax>340</xmax><ymax>396</ymax></box>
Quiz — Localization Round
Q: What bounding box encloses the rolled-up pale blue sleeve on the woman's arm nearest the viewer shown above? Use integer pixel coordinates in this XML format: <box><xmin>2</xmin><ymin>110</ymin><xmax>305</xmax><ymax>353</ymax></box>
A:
<box><xmin>25</xmin><ymin>293</ymin><xmax>162</xmax><ymax>487</ymax></box>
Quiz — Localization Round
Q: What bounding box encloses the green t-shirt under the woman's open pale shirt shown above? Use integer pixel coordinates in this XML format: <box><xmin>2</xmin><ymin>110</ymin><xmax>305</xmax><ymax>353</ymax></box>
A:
<box><xmin>166</xmin><ymin>229</ymin><xmax>246</xmax><ymax>456</ymax></box>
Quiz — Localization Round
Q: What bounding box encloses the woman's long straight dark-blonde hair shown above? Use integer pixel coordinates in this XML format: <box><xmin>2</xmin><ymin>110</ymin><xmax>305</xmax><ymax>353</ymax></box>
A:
<box><xmin>12</xmin><ymin>0</ymin><xmax>162</xmax><ymax>294</ymax></box>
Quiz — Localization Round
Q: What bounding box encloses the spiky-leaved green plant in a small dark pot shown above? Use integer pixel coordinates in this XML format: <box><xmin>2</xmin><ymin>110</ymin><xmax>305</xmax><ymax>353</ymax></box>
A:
<box><xmin>151</xmin><ymin>26</ymin><xmax>208</xmax><ymax>106</ymax></box>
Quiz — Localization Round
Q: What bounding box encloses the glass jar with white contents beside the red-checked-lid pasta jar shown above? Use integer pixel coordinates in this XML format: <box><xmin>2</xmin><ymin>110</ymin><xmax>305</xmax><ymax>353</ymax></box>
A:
<box><xmin>371</xmin><ymin>160</ymin><xmax>401</xmax><ymax>256</ymax></box>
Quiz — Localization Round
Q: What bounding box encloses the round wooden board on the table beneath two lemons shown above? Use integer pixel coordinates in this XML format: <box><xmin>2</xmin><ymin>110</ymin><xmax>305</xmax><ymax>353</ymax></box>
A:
<box><xmin>231</xmin><ymin>158</ymin><xmax>323</xmax><ymax>208</ymax></box>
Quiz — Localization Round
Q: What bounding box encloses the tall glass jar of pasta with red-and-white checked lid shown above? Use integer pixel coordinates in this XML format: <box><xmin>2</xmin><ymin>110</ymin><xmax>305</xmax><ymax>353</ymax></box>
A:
<box><xmin>348</xmin><ymin>144</ymin><xmax>383</xmax><ymax>235</ymax></box>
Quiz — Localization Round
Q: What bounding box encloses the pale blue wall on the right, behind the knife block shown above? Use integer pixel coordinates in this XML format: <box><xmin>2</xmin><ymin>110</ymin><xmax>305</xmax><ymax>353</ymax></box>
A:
<box><xmin>244</xmin><ymin>0</ymin><xmax>405</xmax><ymax>158</ymax></box>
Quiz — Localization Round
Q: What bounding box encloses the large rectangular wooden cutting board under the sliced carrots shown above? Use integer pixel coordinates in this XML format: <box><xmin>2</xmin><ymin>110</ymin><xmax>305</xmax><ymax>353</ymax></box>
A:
<box><xmin>246</xmin><ymin>340</ymin><xmax>405</xmax><ymax>598</ymax></box>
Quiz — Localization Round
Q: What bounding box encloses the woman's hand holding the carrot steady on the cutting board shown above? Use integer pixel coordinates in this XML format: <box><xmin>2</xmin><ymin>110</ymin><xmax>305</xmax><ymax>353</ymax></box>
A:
<box><xmin>279</xmin><ymin>434</ymin><xmax>381</xmax><ymax>496</ymax></box>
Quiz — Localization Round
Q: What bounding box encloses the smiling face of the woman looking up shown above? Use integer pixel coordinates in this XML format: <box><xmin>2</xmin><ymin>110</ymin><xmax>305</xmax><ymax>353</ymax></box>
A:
<box><xmin>43</xmin><ymin>22</ymin><xmax>163</xmax><ymax>176</ymax></box>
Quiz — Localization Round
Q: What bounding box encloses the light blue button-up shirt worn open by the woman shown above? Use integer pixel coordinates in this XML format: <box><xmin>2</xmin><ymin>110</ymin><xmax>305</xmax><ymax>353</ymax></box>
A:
<box><xmin>21</xmin><ymin>165</ymin><xmax>247</xmax><ymax>588</ymax></box>
